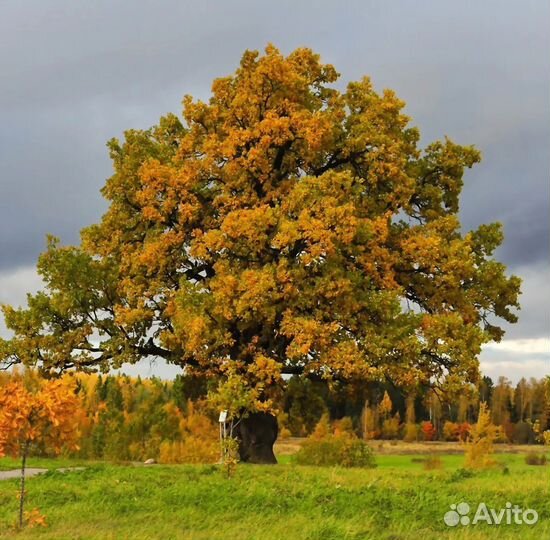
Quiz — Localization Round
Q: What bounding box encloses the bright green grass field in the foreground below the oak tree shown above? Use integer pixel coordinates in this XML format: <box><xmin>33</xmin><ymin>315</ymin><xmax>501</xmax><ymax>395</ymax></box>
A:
<box><xmin>0</xmin><ymin>455</ymin><xmax>550</xmax><ymax>540</ymax></box>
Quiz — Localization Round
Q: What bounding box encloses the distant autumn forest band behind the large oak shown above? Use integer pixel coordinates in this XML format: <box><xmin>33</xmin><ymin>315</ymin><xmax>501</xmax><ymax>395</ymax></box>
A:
<box><xmin>0</xmin><ymin>371</ymin><xmax>550</xmax><ymax>462</ymax></box>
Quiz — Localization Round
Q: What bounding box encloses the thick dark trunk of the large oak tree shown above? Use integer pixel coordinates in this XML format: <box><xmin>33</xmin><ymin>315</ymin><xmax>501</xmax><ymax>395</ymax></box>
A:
<box><xmin>236</xmin><ymin>413</ymin><xmax>279</xmax><ymax>463</ymax></box>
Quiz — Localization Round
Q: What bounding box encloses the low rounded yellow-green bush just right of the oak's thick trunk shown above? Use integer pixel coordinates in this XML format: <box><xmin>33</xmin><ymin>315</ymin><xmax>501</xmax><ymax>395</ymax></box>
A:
<box><xmin>295</xmin><ymin>434</ymin><xmax>375</xmax><ymax>468</ymax></box>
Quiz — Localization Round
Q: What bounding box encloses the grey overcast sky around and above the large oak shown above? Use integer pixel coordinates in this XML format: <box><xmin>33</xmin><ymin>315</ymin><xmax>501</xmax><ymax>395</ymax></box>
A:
<box><xmin>0</xmin><ymin>0</ymin><xmax>550</xmax><ymax>380</ymax></box>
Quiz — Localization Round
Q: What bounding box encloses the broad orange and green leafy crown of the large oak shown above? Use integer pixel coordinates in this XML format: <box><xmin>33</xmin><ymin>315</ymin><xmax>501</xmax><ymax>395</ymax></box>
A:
<box><xmin>0</xmin><ymin>46</ymin><xmax>520</xmax><ymax>459</ymax></box>
